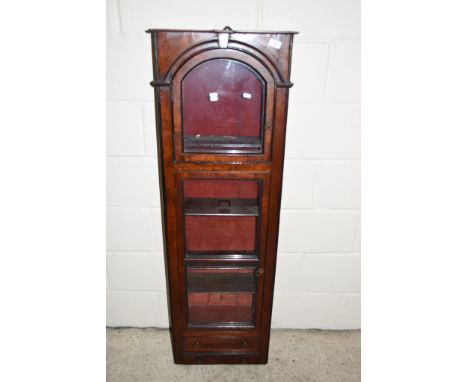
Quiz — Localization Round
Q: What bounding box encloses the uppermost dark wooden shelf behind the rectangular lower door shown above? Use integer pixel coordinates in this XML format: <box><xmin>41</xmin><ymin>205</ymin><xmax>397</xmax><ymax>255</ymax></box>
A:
<box><xmin>185</xmin><ymin>198</ymin><xmax>258</xmax><ymax>216</ymax></box>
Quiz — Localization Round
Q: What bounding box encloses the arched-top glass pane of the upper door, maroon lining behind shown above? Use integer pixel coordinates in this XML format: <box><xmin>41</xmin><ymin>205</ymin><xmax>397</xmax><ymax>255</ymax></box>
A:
<box><xmin>182</xmin><ymin>59</ymin><xmax>264</xmax><ymax>153</ymax></box>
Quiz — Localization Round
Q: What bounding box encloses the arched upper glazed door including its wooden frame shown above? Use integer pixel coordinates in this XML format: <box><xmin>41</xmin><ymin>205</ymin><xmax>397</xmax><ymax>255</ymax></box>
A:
<box><xmin>172</xmin><ymin>50</ymin><xmax>275</xmax><ymax>162</ymax></box>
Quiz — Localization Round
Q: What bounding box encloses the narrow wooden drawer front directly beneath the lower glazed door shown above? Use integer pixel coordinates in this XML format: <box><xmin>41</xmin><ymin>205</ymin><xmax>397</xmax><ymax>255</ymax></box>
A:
<box><xmin>184</xmin><ymin>337</ymin><xmax>258</xmax><ymax>352</ymax></box>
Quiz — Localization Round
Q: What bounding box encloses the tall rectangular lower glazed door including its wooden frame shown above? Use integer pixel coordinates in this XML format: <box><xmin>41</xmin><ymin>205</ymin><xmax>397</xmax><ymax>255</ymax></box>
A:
<box><xmin>176</xmin><ymin>172</ymin><xmax>269</xmax><ymax>333</ymax></box>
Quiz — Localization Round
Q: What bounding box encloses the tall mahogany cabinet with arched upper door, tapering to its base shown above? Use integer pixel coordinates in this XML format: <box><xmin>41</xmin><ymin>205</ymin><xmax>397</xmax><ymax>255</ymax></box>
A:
<box><xmin>147</xmin><ymin>27</ymin><xmax>295</xmax><ymax>364</ymax></box>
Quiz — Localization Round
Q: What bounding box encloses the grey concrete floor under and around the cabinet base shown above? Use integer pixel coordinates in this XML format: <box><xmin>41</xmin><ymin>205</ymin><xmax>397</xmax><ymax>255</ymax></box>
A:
<box><xmin>107</xmin><ymin>328</ymin><xmax>361</xmax><ymax>382</ymax></box>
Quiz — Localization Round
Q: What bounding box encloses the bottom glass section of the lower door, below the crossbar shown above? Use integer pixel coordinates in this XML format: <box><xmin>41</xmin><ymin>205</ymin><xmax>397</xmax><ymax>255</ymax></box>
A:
<box><xmin>187</xmin><ymin>268</ymin><xmax>255</xmax><ymax>325</ymax></box>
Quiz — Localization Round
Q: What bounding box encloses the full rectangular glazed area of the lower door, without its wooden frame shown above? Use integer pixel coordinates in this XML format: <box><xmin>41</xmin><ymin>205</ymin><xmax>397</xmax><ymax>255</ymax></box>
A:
<box><xmin>183</xmin><ymin>179</ymin><xmax>260</xmax><ymax>326</ymax></box>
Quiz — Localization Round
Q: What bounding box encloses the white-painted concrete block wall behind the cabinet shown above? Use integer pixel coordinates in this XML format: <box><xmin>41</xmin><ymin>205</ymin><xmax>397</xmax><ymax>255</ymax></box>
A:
<box><xmin>106</xmin><ymin>0</ymin><xmax>360</xmax><ymax>329</ymax></box>
